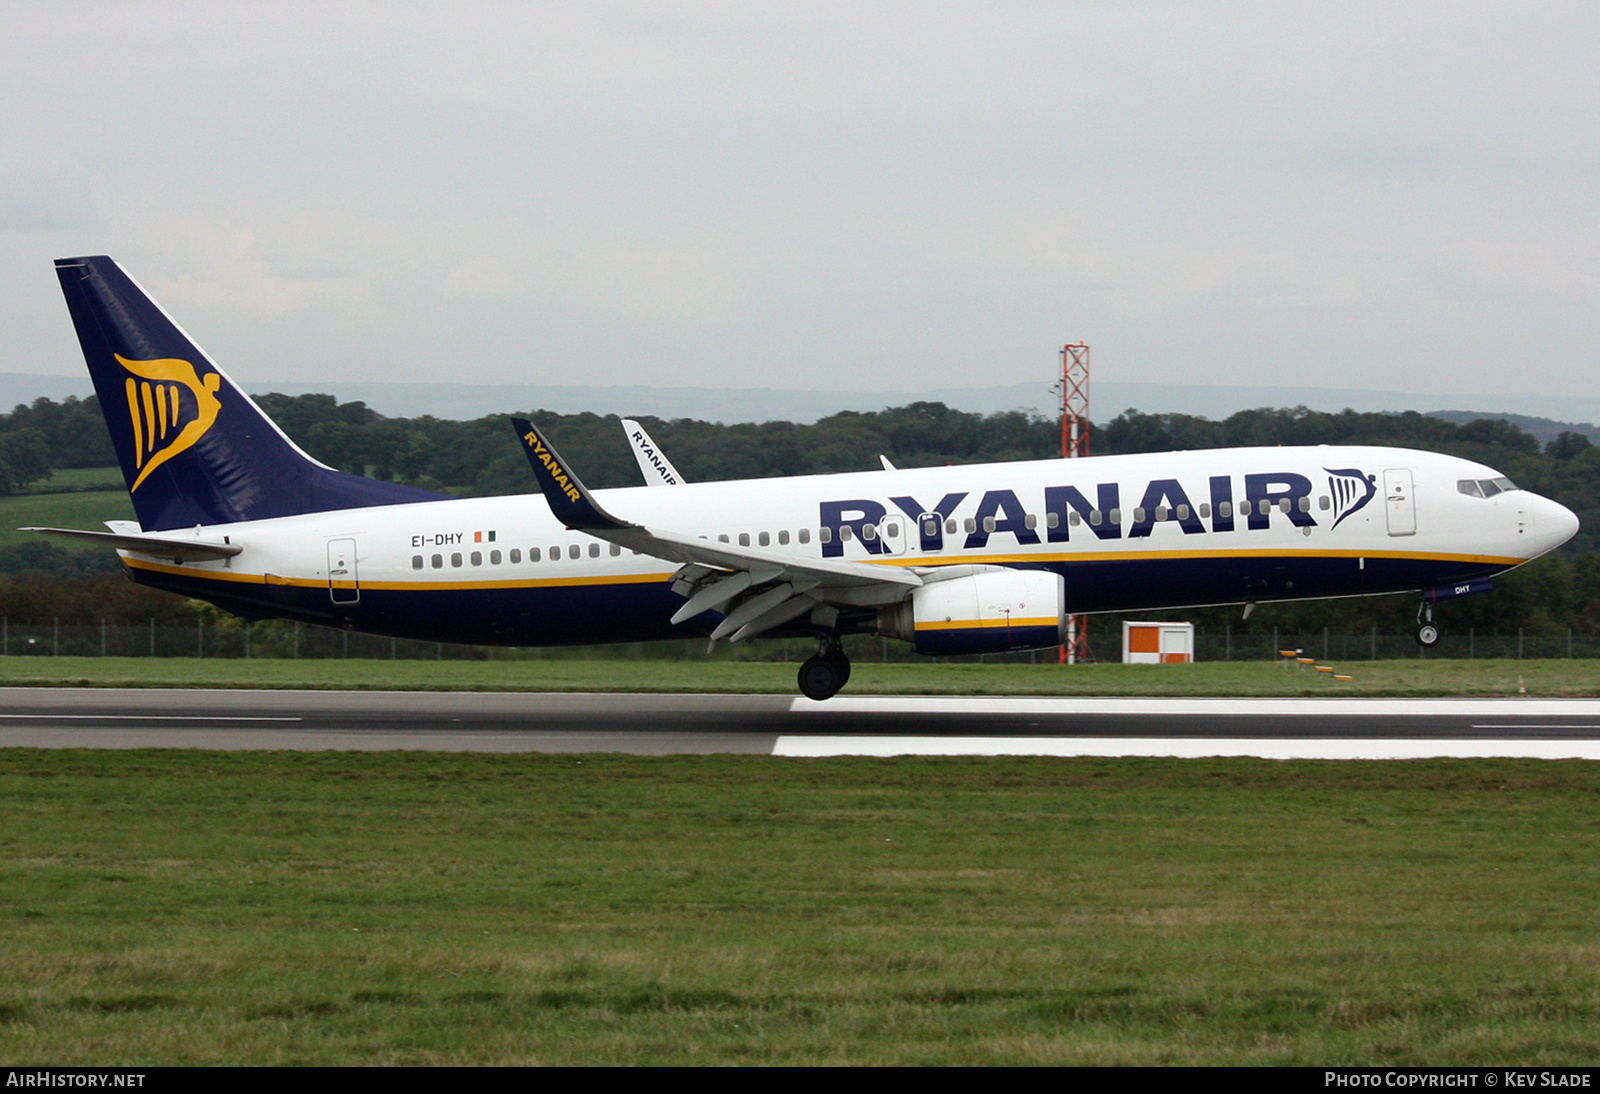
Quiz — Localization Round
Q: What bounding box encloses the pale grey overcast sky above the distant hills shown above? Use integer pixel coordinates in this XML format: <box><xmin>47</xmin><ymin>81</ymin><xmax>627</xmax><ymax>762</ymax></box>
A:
<box><xmin>0</xmin><ymin>0</ymin><xmax>1600</xmax><ymax>403</ymax></box>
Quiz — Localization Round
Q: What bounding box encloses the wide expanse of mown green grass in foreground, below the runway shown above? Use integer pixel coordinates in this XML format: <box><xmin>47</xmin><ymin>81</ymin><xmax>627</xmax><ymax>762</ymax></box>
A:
<box><xmin>0</xmin><ymin>750</ymin><xmax>1600</xmax><ymax>1067</ymax></box>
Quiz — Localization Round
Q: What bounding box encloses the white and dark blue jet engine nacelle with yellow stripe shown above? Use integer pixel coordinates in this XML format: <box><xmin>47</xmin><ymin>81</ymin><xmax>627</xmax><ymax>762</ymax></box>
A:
<box><xmin>878</xmin><ymin>569</ymin><xmax>1067</xmax><ymax>654</ymax></box>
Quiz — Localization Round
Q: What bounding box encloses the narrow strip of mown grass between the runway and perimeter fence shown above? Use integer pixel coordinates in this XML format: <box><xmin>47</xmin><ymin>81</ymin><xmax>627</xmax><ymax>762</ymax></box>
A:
<box><xmin>0</xmin><ymin>657</ymin><xmax>1600</xmax><ymax>697</ymax></box>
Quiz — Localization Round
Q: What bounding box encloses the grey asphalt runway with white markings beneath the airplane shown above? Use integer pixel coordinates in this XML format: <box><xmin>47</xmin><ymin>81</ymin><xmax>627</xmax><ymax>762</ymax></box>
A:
<box><xmin>0</xmin><ymin>688</ymin><xmax>1600</xmax><ymax>760</ymax></box>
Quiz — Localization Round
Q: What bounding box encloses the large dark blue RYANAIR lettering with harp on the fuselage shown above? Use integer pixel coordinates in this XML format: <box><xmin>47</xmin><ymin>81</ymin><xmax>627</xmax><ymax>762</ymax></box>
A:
<box><xmin>818</xmin><ymin>467</ymin><xmax>1378</xmax><ymax>558</ymax></box>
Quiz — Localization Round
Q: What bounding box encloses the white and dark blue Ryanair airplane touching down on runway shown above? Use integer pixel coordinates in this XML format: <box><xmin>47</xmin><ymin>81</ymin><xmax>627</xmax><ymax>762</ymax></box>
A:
<box><xmin>34</xmin><ymin>256</ymin><xmax>1578</xmax><ymax>699</ymax></box>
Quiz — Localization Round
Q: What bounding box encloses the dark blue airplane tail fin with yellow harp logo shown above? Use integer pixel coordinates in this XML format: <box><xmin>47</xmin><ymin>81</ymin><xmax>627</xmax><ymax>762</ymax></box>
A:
<box><xmin>56</xmin><ymin>256</ymin><xmax>443</xmax><ymax>531</ymax></box>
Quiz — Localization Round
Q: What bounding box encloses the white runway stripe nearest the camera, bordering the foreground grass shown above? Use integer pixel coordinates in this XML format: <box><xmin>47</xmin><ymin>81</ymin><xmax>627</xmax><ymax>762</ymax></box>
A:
<box><xmin>773</xmin><ymin>736</ymin><xmax>1600</xmax><ymax>760</ymax></box>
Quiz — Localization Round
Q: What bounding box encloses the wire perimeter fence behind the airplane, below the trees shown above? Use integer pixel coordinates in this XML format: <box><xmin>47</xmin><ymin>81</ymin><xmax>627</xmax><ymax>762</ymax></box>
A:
<box><xmin>0</xmin><ymin>617</ymin><xmax>1600</xmax><ymax>664</ymax></box>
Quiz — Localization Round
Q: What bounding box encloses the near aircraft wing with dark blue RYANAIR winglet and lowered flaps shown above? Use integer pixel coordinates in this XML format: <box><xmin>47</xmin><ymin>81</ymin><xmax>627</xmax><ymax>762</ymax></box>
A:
<box><xmin>512</xmin><ymin>417</ymin><xmax>923</xmax><ymax>641</ymax></box>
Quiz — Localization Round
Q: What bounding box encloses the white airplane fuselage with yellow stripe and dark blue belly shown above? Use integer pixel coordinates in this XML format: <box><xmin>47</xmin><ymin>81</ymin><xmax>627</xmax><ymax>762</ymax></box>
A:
<box><xmin>123</xmin><ymin>446</ymin><xmax>1578</xmax><ymax>645</ymax></box>
